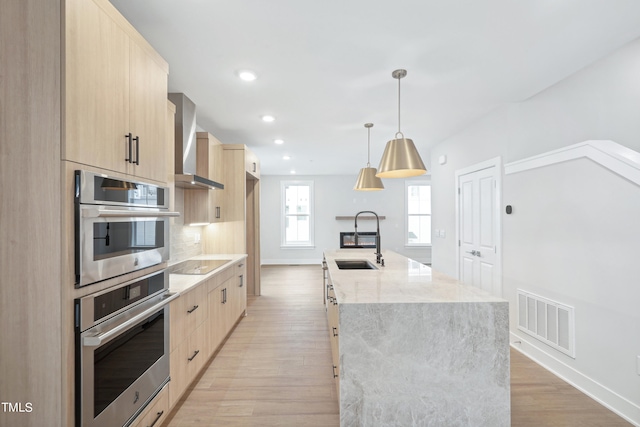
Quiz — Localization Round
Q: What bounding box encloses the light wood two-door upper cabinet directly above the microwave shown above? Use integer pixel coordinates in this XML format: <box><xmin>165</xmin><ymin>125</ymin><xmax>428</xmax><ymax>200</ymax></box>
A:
<box><xmin>63</xmin><ymin>0</ymin><xmax>168</xmax><ymax>182</ymax></box>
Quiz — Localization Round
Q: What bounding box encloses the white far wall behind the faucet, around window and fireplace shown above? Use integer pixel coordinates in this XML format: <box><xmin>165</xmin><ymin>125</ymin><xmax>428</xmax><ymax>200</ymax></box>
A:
<box><xmin>260</xmin><ymin>174</ymin><xmax>431</xmax><ymax>264</ymax></box>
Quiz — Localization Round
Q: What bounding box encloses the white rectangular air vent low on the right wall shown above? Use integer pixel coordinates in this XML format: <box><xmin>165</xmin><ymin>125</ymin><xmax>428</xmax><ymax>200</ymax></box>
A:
<box><xmin>518</xmin><ymin>289</ymin><xmax>576</xmax><ymax>359</ymax></box>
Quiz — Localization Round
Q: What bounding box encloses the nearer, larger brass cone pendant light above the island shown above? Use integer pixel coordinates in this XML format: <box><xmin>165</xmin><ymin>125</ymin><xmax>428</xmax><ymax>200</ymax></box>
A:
<box><xmin>376</xmin><ymin>70</ymin><xmax>427</xmax><ymax>178</ymax></box>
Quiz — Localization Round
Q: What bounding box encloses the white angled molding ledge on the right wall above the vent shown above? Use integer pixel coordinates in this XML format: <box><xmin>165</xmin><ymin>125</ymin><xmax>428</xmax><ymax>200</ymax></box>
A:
<box><xmin>504</xmin><ymin>140</ymin><xmax>640</xmax><ymax>186</ymax></box>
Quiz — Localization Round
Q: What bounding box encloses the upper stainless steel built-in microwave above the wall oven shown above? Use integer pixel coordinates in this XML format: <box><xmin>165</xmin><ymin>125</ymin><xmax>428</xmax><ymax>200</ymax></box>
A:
<box><xmin>74</xmin><ymin>170</ymin><xmax>179</xmax><ymax>287</ymax></box>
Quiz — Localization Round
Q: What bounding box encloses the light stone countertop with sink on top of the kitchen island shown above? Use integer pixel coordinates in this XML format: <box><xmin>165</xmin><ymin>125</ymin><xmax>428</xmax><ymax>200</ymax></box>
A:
<box><xmin>324</xmin><ymin>249</ymin><xmax>505</xmax><ymax>304</ymax></box>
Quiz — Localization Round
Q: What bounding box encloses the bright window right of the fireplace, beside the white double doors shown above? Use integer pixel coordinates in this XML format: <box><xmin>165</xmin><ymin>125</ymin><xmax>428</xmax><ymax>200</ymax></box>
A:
<box><xmin>406</xmin><ymin>181</ymin><xmax>431</xmax><ymax>246</ymax></box>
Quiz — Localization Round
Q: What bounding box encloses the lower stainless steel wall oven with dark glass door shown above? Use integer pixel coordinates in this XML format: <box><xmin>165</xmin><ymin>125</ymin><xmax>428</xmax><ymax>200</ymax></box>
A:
<box><xmin>75</xmin><ymin>271</ymin><xmax>178</xmax><ymax>427</ymax></box>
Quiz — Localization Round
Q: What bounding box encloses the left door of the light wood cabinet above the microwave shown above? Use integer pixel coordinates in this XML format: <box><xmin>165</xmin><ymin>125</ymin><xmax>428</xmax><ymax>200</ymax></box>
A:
<box><xmin>63</xmin><ymin>0</ymin><xmax>130</xmax><ymax>173</ymax></box>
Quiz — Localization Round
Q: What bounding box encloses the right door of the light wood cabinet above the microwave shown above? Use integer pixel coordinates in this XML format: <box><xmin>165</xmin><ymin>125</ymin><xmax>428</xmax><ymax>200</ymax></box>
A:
<box><xmin>130</xmin><ymin>42</ymin><xmax>168</xmax><ymax>182</ymax></box>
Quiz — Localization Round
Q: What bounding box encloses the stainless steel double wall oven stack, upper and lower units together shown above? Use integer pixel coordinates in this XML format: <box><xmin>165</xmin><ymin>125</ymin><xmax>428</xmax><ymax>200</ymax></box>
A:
<box><xmin>74</xmin><ymin>171</ymin><xmax>178</xmax><ymax>427</ymax></box>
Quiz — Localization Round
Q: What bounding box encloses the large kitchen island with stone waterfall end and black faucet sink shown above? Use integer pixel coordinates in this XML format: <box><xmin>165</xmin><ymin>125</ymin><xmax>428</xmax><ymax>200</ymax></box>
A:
<box><xmin>324</xmin><ymin>249</ymin><xmax>510</xmax><ymax>427</ymax></box>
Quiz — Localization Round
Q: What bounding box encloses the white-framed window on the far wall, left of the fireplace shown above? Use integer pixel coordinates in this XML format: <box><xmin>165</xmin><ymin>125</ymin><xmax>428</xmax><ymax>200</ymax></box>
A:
<box><xmin>281</xmin><ymin>181</ymin><xmax>313</xmax><ymax>247</ymax></box>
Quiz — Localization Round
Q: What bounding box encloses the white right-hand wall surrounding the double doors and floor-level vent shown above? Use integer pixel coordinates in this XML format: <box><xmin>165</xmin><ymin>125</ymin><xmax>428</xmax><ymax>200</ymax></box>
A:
<box><xmin>431</xmin><ymin>36</ymin><xmax>640</xmax><ymax>425</ymax></box>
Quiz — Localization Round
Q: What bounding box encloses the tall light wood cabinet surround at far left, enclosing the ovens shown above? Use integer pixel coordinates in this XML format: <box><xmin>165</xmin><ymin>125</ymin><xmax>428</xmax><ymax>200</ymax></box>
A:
<box><xmin>0</xmin><ymin>0</ymin><xmax>170</xmax><ymax>427</ymax></box>
